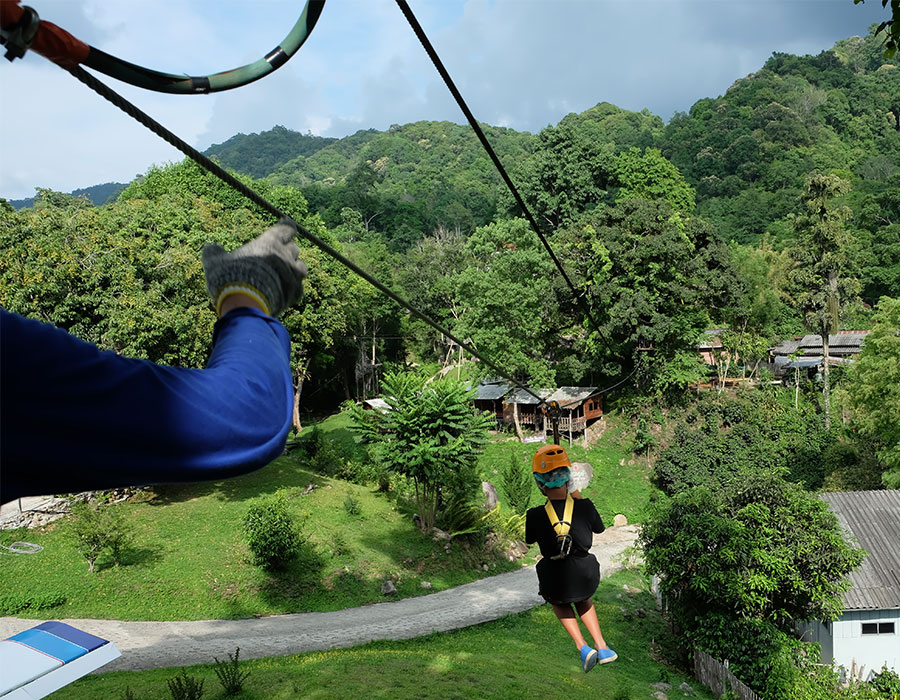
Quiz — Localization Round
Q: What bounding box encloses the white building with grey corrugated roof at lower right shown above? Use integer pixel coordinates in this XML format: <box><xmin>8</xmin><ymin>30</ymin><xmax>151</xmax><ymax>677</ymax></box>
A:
<box><xmin>803</xmin><ymin>490</ymin><xmax>900</xmax><ymax>680</ymax></box>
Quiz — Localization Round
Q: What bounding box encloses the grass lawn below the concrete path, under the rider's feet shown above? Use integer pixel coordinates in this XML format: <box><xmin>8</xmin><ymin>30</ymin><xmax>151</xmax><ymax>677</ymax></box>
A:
<box><xmin>53</xmin><ymin>572</ymin><xmax>713</xmax><ymax>700</ymax></box>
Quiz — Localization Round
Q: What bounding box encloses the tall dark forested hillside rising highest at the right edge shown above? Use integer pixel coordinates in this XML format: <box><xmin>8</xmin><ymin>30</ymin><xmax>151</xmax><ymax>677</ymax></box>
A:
<box><xmin>659</xmin><ymin>37</ymin><xmax>900</xmax><ymax>249</ymax></box>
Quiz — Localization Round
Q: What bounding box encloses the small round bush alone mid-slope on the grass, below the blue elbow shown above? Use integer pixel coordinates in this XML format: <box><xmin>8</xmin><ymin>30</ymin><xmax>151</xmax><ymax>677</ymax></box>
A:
<box><xmin>242</xmin><ymin>490</ymin><xmax>304</xmax><ymax>569</ymax></box>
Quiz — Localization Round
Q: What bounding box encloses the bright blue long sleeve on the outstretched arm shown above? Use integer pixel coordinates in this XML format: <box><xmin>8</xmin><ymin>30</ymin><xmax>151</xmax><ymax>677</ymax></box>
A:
<box><xmin>0</xmin><ymin>309</ymin><xmax>293</xmax><ymax>502</ymax></box>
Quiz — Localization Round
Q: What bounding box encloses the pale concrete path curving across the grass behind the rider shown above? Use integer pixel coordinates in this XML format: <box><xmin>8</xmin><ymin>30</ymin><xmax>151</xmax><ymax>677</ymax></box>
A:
<box><xmin>0</xmin><ymin>525</ymin><xmax>638</xmax><ymax>672</ymax></box>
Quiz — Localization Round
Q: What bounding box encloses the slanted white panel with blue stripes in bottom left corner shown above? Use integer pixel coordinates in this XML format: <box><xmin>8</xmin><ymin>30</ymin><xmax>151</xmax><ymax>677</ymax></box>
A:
<box><xmin>0</xmin><ymin>622</ymin><xmax>122</xmax><ymax>700</ymax></box>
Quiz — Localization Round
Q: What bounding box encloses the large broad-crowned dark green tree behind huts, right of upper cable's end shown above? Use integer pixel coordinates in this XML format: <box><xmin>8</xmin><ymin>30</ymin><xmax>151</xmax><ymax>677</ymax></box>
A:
<box><xmin>559</xmin><ymin>198</ymin><xmax>735</xmax><ymax>391</ymax></box>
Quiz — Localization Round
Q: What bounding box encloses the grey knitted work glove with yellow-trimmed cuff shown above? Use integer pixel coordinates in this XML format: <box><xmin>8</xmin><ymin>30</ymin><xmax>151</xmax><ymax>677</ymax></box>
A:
<box><xmin>203</xmin><ymin>218</ymin><xmax>307</xmax><ymax>317</ymax></box>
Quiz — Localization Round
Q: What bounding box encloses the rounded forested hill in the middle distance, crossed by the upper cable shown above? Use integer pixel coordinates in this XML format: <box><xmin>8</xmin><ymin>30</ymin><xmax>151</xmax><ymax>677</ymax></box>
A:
<box><xmin>272</xmin><ymin>122</ymin><xmax>534</xmax><ymax>250</ymax></box>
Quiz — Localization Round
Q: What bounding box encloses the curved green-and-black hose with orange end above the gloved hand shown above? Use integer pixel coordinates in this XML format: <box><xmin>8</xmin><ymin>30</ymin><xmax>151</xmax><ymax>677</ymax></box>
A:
<box><xmin>2</xmin><ymin>0</ymin><xmax>325</xmax><ymax>95</ymax></box>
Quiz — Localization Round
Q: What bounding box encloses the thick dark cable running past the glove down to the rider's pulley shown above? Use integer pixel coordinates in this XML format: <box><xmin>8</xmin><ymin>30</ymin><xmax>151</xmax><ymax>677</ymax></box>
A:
<box><xmin>66</xmin><ymin>66</ymin><xmax>543</xmax><ymax>402</ymax></box>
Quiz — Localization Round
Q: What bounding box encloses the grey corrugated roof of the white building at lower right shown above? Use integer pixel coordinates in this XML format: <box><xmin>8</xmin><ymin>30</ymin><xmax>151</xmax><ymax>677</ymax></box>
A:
<box><xmin>821</xmin><ymin>490</ymin><xmax>900</xmax><ymax>610</ymax></box>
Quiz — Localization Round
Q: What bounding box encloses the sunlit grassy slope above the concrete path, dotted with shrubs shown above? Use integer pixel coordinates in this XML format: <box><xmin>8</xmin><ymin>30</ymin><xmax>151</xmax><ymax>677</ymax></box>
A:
<box><xmin>0</xmin><ymin>415</ymin><xmax>650</xmax><ymax>620</ymax></box>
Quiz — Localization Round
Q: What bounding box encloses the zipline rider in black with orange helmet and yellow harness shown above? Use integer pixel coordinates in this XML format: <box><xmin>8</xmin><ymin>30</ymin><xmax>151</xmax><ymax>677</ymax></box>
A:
<box><xmin>525</xmin><ymin>445</ymin><xmax>616</xmax><ymax>673</ymax></box>
